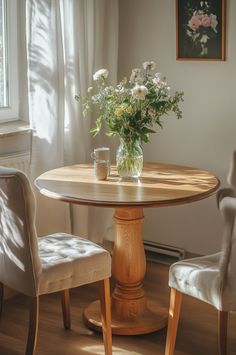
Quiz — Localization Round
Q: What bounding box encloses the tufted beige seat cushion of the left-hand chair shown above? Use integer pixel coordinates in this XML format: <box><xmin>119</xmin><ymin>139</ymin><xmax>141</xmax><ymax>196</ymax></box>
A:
<box><xmin>38</xmin><ymin>233</ymin><xmax>111</xmax><ymax>295</ymax></box>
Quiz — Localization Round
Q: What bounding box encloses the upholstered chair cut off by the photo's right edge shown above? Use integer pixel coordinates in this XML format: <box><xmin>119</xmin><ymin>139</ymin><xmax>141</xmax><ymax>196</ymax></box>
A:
<box><xmin>165</xmin><ymin>193</ymin><xmax>236</xmax><ymax>355</ymax></box>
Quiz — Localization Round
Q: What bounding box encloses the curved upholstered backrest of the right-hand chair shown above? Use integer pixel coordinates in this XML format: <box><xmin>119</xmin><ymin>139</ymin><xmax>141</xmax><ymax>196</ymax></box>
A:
<box><xmin>219</xmin><ymin>196</ymin><xmax>236</xmax><ymax>311</ymax></box>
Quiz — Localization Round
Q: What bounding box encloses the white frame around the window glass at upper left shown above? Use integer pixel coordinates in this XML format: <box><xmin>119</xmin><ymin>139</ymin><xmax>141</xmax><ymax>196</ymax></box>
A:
<box><xmin>0</xmin><ymin>0</ymin><xmax>19</xmax><ymax>123</ymax></box>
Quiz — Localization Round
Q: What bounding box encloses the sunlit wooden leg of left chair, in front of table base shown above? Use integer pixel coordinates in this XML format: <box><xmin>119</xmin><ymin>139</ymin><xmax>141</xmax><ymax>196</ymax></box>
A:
<box><xmin>99</xmin><ymin>279</ymin><xmax>112</xmax><ymax>355</ymax></box>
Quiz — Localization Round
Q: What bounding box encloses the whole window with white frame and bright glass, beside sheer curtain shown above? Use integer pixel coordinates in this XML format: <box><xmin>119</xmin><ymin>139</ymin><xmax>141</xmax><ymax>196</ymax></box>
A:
<box><xmin>0</xmin><ymin>0</ymin><xmax>18</xmax><ymax>122</ymax></box>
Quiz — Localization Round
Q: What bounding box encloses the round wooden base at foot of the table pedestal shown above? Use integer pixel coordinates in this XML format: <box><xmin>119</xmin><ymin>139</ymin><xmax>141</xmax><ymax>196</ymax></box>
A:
<box><xmin>83</xmin><ymin>300</ymin><xmax>168</xmax><ymax>335</ymax></box>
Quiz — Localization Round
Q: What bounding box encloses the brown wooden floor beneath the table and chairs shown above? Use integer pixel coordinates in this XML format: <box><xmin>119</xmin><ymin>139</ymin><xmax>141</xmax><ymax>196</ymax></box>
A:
<box><xmin>0</xmin><ymin>263</ymin><xmax>236</xmax><ymax>355</ymax></box>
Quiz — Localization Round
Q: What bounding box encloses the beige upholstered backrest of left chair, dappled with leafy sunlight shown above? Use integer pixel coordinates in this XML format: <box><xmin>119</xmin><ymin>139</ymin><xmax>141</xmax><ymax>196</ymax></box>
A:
<box><xmin>0</xmin><ymin>167</ymin><xmax>41</xmax><ymax>296</ymax></box>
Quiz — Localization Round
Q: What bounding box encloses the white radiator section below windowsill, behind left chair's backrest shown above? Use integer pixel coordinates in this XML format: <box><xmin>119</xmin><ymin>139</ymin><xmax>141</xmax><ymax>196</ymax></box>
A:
<box><xmin>0</xmin><ymin>151</ymin><xmax>31</xmax><ymax>175</ymax></box>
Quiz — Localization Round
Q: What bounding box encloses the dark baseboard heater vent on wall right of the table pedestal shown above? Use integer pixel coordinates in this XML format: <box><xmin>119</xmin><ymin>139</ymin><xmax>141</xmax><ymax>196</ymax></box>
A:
<box><xmin>143</xmin><ymin>240</ymin><xmax>185</xmax><ymax>264</ymax></box>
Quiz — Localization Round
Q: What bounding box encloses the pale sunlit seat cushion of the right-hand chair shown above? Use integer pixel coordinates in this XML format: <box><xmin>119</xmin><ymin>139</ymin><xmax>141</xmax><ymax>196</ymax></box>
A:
<box><xmin>169</xmin><ymin>253</ymin><xmax>222</xmax><ymax>310</ymax></box>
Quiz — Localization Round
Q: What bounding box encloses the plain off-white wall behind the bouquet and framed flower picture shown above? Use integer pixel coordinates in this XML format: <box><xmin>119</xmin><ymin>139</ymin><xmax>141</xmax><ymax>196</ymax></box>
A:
<box><xmin>119</xmin><ymin>0</ymin><xmax>236</xmax><ymax>254</ymax></box>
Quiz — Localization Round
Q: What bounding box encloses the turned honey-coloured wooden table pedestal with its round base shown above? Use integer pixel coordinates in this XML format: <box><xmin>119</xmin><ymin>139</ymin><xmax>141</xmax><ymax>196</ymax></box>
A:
<box><xmin>84</xmin><ymin>208</ymin><xmax>167</xmax><ymax>335</ymax></box>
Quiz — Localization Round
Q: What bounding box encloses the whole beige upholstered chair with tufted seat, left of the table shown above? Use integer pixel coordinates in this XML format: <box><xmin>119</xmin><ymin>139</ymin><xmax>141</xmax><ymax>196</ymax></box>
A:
<box><xmin>0</xmin><ymin>167</ymin><xmax>112</xmax><ymax>355</ymax></box>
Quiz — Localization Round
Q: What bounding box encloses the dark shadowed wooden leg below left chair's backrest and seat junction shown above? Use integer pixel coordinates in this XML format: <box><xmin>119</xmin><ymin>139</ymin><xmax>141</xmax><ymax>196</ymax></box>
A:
<box><xmin>25</xmin><ymin>297</ymin><xmax>39</xmax><ymax>355</ymax></box>
